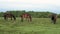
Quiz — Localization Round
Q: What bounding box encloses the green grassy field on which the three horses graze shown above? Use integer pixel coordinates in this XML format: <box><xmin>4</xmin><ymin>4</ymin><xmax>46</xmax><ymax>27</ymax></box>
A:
<box><xmin>0</xmin><ymin>18</ymin><xmax>60</xmax><ymax>34</ymax></box>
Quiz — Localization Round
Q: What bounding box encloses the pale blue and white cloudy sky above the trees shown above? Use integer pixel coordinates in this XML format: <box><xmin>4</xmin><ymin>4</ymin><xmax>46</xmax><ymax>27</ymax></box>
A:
<box><xmin>0</xmin><ymin>0</ymin><xmax>60</xmax><ymax>14</ymax></box>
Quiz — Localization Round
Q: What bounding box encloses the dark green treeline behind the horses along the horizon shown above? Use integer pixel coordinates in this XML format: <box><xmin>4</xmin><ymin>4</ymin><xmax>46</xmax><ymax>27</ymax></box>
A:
<box><xmin>0</xmin><ymin>10</ymin><xmax>60</xmax><ymax>18</ymax></box>
